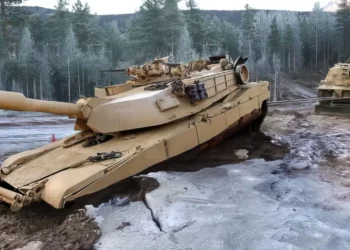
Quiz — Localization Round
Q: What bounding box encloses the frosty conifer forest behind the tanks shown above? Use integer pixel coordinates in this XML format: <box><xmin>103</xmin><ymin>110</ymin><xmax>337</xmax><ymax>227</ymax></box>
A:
<box><xmin>0</xmin><ymin>0</ymin><xmax>350</xmax><ymax>102</ymax></box>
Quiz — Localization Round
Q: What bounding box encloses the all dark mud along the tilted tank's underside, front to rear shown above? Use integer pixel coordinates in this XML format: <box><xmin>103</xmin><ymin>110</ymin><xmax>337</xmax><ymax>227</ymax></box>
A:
<box><xmin>0</xmin><ymin>111</ymin><xmax>288</xmax><ymax>249</ymax></box>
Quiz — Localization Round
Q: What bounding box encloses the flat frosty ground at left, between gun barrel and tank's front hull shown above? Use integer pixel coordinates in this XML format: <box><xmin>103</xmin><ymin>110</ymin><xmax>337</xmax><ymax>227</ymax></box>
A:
<box><xmin>0</xmin><ymin>110</ymin><xmax>75</xmax><ymax>165</ymax></box>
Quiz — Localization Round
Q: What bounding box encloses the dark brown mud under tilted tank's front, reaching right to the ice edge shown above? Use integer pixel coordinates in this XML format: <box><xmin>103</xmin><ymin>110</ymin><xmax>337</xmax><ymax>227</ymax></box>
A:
<box><xmin>0</xmin><ymin>178</ymin><xmax>159</xmax><ymax>250</ymax></box>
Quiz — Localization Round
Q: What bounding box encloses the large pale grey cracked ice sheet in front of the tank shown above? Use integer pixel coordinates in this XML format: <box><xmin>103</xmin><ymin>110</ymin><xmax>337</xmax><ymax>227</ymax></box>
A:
<box><xmin>91</xmin><ymin>159</ymin><xmax>350</xmax><ymax>250</ymax></box>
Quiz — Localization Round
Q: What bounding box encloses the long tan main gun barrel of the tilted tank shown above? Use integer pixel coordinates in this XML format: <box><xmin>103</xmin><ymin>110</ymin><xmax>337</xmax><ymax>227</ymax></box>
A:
<box><xmin>0</xmin><ymin>91</ymin><xmax>82</xmax><ymax>118</ymax></box>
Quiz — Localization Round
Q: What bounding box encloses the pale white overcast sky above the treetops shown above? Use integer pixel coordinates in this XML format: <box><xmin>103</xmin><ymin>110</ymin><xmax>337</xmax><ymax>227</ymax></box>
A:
<box><xmin>21</xmin><ymin>0</ymin><xmax>332</xmax><ymax>15</ymax></box>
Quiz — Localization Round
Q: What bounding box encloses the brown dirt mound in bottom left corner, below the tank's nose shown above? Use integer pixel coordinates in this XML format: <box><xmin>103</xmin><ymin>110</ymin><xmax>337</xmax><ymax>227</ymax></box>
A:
<box><xmin>0</xmin><ymin>204</ymin><xmax>101</xmax><ymax>250</ymax></box>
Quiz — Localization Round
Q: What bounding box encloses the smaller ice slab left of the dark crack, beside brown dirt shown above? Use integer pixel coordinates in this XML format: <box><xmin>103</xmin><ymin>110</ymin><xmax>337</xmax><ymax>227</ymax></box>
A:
<box><xmin>90</xmin><ymin>202</ymin><xmax>185</xmax><ymax>250</ymax></box>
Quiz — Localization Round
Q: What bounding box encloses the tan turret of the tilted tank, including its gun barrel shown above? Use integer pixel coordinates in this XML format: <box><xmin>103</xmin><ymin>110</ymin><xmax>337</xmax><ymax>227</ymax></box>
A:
<box><xmin>0</xmin><ymin>54</ymin><xmax>249</xmax><ymax>133</ymax></box>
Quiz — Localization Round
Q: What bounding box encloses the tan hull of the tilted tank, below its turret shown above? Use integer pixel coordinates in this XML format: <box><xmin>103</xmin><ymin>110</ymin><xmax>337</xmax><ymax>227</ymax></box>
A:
<box><xmin>0</xmin><ymin>82</ymin><xmax>270</xmax><ymax>211</ymax></box>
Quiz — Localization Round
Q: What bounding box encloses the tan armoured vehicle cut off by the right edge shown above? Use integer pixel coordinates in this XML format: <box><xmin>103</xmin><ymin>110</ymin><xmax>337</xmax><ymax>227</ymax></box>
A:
<box><xmin>315</xmin><ymin>60</ymin><xmax>350</xmax><ymax>115</ymax></box>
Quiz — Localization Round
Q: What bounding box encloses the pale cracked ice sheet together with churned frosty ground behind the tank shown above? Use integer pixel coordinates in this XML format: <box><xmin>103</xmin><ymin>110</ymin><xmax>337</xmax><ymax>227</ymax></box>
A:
<box><xmin>86</xmin><ymin>105</ymin><xmax>350</xmax><ymax>250</ymax></box>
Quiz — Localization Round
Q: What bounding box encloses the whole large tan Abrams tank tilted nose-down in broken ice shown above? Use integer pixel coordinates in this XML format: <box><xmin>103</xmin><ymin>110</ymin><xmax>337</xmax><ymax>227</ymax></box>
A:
<box><xmin>0</xmin><ymin>56</ymin><xmax>270</xmax><ymax>212</ymax></box>
